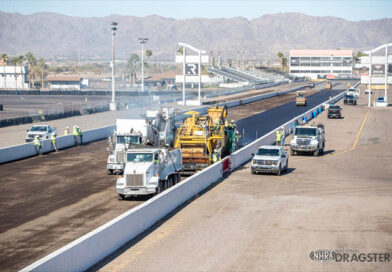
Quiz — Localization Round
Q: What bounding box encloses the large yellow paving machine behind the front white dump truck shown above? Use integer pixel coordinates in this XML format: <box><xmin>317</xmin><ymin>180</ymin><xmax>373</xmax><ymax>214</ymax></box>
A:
<box><xmin>174</xmin><ymin>106</ymin><xmax>238</xmax><ymax>175</ymax></box>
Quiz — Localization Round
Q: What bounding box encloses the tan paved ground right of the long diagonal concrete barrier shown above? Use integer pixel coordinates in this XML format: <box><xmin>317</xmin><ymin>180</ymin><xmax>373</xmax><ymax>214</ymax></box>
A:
<box><xmin>91</xmin><ymin>88</ymin><xmax>392</xmax><ymax>271</ymax></box>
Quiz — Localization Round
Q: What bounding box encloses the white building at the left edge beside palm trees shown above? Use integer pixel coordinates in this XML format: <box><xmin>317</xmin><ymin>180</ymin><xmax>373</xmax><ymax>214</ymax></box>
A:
<box><xmin>0</xmin><ymin>65</ymin><xmax>29</xmax><ymax>89</ymax></box>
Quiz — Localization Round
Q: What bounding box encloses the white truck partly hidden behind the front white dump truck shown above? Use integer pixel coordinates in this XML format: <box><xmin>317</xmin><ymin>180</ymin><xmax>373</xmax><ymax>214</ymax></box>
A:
<box><xmin>107</xmin><ymin>119</ymin><xmax>159</xmax><ymax>174</ymax></box>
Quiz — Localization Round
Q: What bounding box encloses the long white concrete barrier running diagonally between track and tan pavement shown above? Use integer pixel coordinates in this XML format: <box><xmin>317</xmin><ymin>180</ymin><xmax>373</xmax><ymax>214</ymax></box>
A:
<box><xmin>22</xmin><ymin>88</ymin><xmax>343</xmax><ymax>271</ymax></box>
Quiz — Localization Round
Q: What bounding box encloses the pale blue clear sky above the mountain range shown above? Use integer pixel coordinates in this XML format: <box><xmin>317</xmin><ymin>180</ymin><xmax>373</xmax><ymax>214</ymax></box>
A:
<box><xmin>0</xmin><ymin>0</ymin><xmax>392</xmax><ymax>21</ymax></box>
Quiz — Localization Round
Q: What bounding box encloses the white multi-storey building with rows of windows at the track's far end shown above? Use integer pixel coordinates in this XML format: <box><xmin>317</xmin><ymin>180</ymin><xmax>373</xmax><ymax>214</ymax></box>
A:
<box><xmin>289</xmin><ymin>50</ymin><xmax>353</xmax><ymax>79</ymax></box>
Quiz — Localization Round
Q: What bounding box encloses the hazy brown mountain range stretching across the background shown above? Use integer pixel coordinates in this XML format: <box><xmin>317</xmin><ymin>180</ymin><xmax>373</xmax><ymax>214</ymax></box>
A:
<box><xmin>0</xmin><ymin>12</ymin><xmax>392</xmax><ymax>60</ymax></box>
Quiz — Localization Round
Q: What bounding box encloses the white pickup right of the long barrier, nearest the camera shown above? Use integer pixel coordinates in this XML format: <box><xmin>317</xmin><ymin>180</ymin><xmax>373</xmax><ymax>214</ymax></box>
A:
<box><xmin>250</xmin><ymin>145</ymin><xmax>289</xmax><ymax>176</ymax></box>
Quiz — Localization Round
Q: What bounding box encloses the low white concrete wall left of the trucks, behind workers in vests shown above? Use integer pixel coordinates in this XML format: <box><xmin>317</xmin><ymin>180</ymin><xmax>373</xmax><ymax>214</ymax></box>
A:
<box><xmin>0</xmin><ymin>126</ymin><xmax>115</xmax><ymax>163</ymax></box>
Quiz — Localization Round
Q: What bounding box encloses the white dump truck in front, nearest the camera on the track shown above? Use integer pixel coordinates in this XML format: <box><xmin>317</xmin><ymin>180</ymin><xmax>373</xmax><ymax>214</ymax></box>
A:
<box><xmin>116</xmin><ymin>147</ymin><xmax>182</xmax><ymax>200</ymax></box>
